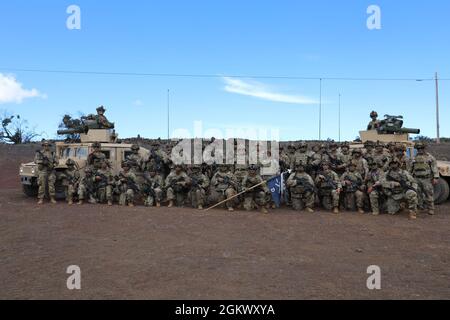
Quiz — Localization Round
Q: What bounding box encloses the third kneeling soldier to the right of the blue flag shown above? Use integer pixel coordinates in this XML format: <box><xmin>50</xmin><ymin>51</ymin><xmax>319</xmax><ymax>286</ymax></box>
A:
<box><xmin>341</xmin><ymin>163</ymin><xmax>364</xmax><ymax>213</ymax></box>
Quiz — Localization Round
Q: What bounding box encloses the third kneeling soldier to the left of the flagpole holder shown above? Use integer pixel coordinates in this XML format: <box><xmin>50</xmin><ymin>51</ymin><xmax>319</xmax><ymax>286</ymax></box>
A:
<box><xmin>165</xmin><ymin>164</ymin><xmax>191</xmax><ymax>208</ymax></box>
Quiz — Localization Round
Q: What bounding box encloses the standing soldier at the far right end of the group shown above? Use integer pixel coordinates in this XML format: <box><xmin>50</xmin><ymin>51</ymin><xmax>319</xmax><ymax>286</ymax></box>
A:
<box><xmin>411</xmin><ymin>142</ymin><xmax>439</xmax><ymax>215</ymax></box>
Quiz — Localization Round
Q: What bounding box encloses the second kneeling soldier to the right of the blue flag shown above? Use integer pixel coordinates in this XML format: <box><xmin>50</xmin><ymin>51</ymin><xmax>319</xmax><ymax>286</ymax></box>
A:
<box><xmin>316</xmin><ymin>162</ymin><xmax>342</xmax><ymax>214</ymax></box>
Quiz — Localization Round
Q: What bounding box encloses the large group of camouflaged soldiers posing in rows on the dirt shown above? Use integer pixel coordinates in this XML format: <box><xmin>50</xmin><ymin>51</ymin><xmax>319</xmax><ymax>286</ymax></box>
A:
<box><xmin>35</xmin><ymin>136</ymin><xmax>439</xmax><ymax>219</ymax></box>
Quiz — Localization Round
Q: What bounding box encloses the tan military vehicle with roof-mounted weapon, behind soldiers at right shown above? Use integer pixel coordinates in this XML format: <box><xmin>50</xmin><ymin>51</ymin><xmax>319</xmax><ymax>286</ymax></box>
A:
<box><xmin>351</xmin><ymin>115</ymin><xmax>450</xmax><ymax>204</ymax></box>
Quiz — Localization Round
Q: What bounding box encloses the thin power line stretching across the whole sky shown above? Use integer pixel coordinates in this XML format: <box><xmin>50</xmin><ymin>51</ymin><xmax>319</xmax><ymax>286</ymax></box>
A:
<box><xmin>0</xmin><ymin>67</ymin><xmax>450</xmax><ymax>82</ymax></box>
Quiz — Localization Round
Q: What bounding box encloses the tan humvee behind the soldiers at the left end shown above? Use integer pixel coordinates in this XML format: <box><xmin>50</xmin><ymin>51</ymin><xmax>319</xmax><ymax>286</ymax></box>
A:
<box><xmin>19</xmin><ymin>129</ymin><xmax>150</xmax><ymax>198</ymax></box>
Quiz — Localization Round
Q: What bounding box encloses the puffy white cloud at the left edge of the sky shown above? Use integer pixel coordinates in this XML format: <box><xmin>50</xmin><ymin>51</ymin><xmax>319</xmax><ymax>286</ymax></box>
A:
<box><xmin>0</xmin><ymin>73</ymin><xmax>46</xmax><ymax>104</ymax></box>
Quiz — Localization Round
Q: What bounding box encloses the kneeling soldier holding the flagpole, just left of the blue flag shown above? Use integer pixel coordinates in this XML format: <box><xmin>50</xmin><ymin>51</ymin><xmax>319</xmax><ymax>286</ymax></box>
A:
<box><xmin>242</xmin><ymin>165</ymin><xmax>269</xmax><ymax>214</ymax></box>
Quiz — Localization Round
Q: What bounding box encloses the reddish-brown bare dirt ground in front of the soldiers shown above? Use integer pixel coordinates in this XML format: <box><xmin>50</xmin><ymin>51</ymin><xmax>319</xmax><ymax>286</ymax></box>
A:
<box><xmin>0</xmin><ymin>146</ymin><xmax>450</xmax><ymax>299</ymax></box>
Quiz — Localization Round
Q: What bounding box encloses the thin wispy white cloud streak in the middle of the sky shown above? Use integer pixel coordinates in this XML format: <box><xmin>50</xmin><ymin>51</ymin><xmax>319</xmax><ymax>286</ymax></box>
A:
<box><xmin>223</xmin><ymin>77</ymin><xmax>318</xmax><ymax>104</ymax></box>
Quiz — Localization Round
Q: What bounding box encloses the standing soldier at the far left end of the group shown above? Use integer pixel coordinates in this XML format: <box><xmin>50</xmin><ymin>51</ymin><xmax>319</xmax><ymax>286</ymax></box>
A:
<box><xmin>34</xmin><ymin>140</ymin><xmax>57</xmax><ymax>204</ymax></box>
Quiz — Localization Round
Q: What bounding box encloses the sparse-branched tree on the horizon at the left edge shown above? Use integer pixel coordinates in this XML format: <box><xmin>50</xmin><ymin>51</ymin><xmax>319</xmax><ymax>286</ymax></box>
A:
<box><xmin>0</xmin><ymin>114</ymin><xmax>40</xmax><ymax>144</ymax></box>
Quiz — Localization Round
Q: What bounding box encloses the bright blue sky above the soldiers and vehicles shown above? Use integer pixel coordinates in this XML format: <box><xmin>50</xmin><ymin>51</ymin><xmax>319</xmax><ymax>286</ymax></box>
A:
<box><xmin>0</xmin><ymin>0</ymin><xmax>450</xmax><ymax>140</ymax></box>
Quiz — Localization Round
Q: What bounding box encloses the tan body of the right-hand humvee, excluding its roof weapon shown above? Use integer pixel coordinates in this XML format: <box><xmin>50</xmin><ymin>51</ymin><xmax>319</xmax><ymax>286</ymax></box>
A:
<box><xmin>351</xmin><ymin>130</ymin><xmax>450</xmax><ymax>204</ymax></box>
